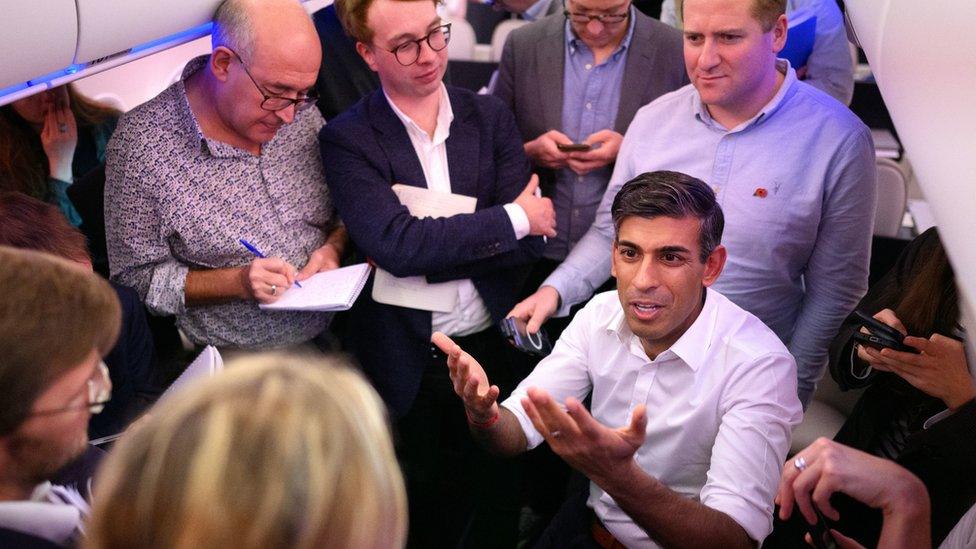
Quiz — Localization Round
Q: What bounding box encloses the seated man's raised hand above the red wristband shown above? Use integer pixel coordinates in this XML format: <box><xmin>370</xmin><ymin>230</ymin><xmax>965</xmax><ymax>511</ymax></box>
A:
<box><xmin>430</xmin><ymin>332</ymin><xmax>499</xmax><ymax>423</ymax></box>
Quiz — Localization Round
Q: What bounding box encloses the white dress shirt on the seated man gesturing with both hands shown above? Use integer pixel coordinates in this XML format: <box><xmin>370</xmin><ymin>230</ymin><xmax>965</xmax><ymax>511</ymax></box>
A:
<box><xmin>502</xmin><ymin>290</ymin><xmax>802</xmax><ymax>547</ymax></box>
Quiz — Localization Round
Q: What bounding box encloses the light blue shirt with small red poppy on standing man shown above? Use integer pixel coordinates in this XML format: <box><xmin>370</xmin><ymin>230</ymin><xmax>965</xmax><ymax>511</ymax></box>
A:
<box><xmin>544</xmin><ymin>65</ymin><xmax>877</xmax><ymax>403</ymax></box>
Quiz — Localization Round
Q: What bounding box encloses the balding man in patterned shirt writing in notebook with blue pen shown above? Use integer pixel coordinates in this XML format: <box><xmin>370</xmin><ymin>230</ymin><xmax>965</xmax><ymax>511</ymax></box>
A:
<box><xmin>105</xmin><ymin>0</ymin><xmax>345</xmax><ymax>349</ymax></box>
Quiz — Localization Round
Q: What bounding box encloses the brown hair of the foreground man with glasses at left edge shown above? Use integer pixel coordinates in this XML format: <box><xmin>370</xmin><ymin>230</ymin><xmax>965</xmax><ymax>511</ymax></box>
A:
<box><xmin>0</xmin><ymin>246</ymin><xmax>122</xmax><ymax>436</ymax></box>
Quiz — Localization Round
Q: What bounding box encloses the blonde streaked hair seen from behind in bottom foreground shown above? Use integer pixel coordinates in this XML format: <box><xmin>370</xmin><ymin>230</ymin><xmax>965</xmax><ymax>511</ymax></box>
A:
<box><xmin>86</xmin><ymin>354</ymin><xmax>406</xmax><ymax>549</ymax></box>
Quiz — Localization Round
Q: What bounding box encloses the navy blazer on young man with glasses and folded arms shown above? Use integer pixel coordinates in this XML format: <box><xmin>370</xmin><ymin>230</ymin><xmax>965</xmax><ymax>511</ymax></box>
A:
<box><xmin>319</xmin><ymin>87</ymin><xmax>543</xmax><ymax>418</ymax></box>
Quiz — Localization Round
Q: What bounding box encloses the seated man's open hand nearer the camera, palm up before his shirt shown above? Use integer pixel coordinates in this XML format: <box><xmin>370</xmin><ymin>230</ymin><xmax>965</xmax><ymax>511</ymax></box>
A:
<box><xmin>522</xmin><ymin>387</ymin><xmax>647</xmax><ymax>486</ymax></box>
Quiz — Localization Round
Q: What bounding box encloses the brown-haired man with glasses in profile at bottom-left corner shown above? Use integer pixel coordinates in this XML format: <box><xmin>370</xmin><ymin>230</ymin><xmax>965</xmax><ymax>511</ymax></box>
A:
<box><xmin>0</xmin><ymin>246</ymin><xmax>121</xmax><ymax>548</ymax></box>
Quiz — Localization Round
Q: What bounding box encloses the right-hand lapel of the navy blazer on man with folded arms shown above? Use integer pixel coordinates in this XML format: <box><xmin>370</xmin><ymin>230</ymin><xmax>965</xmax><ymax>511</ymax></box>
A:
<box><xmin>447</xmin><ymin>88</ymin><xmax>481</xmax><ymax>198</ymax></box>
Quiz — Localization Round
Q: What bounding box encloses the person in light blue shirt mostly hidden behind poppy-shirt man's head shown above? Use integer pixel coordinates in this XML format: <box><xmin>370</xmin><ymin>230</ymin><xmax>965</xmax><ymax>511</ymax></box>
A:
<box><xmin>661</xmin><ymin>0</ymin><xmax>854</xmax><ymax>105</ymax></box>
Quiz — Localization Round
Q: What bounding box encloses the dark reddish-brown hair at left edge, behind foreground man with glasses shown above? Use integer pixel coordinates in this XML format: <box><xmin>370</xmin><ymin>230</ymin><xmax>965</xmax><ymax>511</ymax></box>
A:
<box><xmin>0</xmin><ymin>191</ymin><xmax>91</xmax><ymax>262</ymax></box>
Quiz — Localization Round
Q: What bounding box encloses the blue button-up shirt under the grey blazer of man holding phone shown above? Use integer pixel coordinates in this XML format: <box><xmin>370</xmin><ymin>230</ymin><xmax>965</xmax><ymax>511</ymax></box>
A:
<box><xmin>543</xmin><ymin>10</ymin><xmax>635</xmax><ymax>261</ymax></box>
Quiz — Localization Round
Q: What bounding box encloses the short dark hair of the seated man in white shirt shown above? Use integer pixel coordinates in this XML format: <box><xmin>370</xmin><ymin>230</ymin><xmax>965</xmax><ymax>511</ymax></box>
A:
<box><xmin>610</xmin><ymin>171</ymin><xmax>725</xmax><ymax>262</ymax></box>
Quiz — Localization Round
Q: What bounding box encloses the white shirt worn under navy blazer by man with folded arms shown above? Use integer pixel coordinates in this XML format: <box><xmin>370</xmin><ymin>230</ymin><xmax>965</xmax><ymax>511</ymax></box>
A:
<box><xmin>383</xmin><ymin>84</ymin><xmax>529</xmax><ymax>336</ymax></box>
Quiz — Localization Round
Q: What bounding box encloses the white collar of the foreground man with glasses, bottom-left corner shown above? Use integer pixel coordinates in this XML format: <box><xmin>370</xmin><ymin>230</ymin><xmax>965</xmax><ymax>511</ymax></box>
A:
<box><xmin>0</xmin><ymin>482</ymin><xmax>82</xmax><ymax>545</ymax></box>
